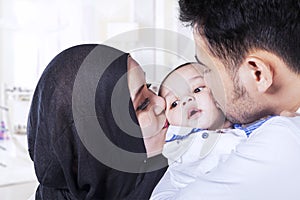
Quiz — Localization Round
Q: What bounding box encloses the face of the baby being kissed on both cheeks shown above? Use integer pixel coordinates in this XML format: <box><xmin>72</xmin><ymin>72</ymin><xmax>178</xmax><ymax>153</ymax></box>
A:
<box><xmin>161</xmin><ymin>64</ymin><xmax>225</xmax><ymax>129</ymax></box>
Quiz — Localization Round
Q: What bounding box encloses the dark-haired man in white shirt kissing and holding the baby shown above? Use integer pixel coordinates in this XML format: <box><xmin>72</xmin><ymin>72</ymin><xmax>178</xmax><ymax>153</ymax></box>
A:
<box><xmin>154</xmin><ymin>0</ymin><xmax>300</xmax><ymax>200</ymax></box>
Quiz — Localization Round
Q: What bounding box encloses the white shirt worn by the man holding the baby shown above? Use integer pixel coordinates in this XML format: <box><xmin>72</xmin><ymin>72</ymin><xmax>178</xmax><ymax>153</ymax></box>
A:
<box><xmin>151</xmin><ymin>117</ymin><xmax>300</xmax><ymax>200</ymax></box>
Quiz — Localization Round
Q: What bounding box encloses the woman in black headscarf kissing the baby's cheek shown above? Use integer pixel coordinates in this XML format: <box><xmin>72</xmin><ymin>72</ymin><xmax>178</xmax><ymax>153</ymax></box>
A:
<box><xmin>27</xmin><ymin>45</ymin><xmax>166</xmax><ymax>200</ymax></box>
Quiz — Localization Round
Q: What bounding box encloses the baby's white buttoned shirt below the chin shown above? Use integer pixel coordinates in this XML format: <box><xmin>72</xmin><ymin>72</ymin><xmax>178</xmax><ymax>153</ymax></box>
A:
<box><xmin>159</xmin><ymin>126</ymin><xmax>247</xmax><ymax>190</ymax></box>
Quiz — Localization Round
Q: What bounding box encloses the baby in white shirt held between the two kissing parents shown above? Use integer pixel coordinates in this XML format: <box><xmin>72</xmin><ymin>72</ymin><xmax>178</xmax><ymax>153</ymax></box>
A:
<box><xmin>152</xmin><ymin>63</ymin><xmax>247</xmax><ymax>195</ymax></box>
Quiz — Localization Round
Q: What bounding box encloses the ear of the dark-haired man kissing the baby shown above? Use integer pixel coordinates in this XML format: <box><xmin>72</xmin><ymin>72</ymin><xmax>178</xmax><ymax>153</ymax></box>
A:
<box><xmin>244</xmin><ymin>55</ymin><xmax>273</xmax><ymax>93</ymax></box>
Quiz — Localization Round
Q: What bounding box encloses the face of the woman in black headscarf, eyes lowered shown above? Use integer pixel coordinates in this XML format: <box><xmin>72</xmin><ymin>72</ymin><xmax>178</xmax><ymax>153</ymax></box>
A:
<box><xmin>128</xmin><ymin>57</ymin><xmax>168</xmax><ymax>156</ymax></box>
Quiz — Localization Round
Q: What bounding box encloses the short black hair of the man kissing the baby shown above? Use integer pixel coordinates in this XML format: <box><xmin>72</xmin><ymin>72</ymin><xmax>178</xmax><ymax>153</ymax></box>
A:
<box><xmin>179</xmin><ymin>0</ymin><xmax>300</xmax><ymax>73</ymax></box>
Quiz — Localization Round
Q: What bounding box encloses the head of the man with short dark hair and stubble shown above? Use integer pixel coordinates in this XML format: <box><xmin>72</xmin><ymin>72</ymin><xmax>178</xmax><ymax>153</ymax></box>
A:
<box><xmin>179</xmin><ymin>0</ymin><xmax>300</xmax><ymax>123</ymax></box>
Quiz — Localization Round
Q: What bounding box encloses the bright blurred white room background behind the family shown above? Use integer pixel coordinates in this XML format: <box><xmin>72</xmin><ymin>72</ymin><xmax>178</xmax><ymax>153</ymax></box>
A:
<box><xmin>0</xmin><ymin>0</ymin><xmax>194</xmax><ymax>200</ymax></box>
